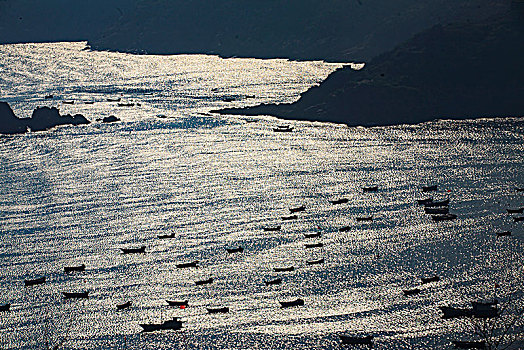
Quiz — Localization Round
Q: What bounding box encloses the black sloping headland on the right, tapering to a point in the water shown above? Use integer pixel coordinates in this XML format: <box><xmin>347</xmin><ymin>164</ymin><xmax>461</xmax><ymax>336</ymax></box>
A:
<box><xmin>217</xmin><ymin>6</ymin><xmax>524</xmax><ymax>126</ymax></box>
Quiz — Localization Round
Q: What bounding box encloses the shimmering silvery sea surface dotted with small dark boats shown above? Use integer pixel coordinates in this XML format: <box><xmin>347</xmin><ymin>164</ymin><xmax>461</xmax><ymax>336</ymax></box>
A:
<box><xmin>0</xmin><ymin>43</ymin><xmax>524</xmax><ymax>349</ymax></box>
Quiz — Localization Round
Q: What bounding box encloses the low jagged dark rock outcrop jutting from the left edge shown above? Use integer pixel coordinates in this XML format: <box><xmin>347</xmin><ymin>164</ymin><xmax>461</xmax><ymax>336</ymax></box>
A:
<box><xmin>0</xmin><ymin>102</ymin><xmax>89</xmax><ymax>134</ymax></box>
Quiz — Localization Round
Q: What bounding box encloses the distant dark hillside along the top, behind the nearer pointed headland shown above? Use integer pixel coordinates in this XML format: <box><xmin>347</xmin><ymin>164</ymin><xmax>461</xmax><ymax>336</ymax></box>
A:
<box><xmin>89</xmin><ymin>0</ymin><xmax>510</xmax><ymax>62</ymax></box>
